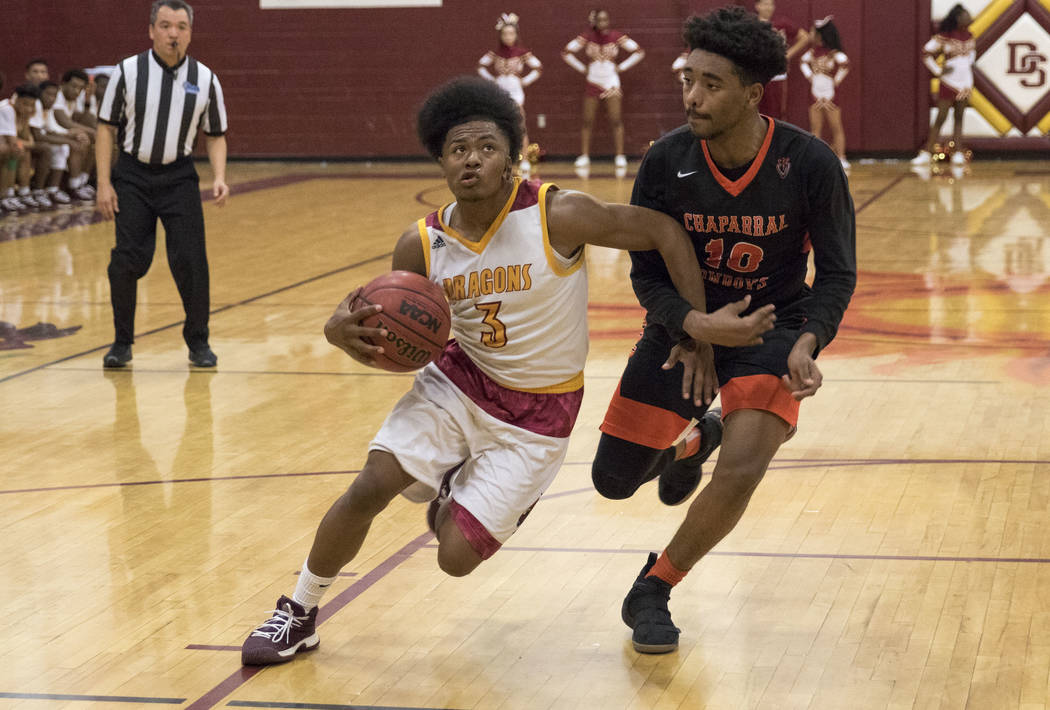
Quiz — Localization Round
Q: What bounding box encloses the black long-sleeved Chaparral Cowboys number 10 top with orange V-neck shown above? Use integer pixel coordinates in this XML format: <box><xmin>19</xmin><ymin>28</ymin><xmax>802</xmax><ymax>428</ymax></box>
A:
<box><xmin>631</xmin><ymin>121</ymin><xmax>857</xmax><ymax>355</ymax></box>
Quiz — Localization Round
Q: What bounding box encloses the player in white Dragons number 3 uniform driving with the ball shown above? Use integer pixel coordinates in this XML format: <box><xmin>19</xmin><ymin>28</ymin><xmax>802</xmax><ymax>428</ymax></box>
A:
<box><xmin>242</xmin><ymin>77</ymin><xmax>774</xmax><ymax>665</ymax></box>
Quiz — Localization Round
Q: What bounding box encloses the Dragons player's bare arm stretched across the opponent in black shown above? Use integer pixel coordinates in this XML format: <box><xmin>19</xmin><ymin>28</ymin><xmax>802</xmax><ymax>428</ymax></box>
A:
<box><xmin>547</xmin><ymin>186</ymin><xmax>775</xmax><ymax>347</ymax></box>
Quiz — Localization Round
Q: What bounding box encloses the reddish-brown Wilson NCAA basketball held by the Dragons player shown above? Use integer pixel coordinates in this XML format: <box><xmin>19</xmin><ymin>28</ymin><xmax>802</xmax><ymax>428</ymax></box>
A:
<box><xmin>350</xmin><ymin>271</ymin><xmax>452</xmax><ymax>372</ymax></box>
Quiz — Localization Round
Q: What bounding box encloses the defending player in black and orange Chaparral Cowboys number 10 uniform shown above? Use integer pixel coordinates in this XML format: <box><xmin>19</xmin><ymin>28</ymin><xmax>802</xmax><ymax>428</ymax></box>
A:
<box><xmin>592</xmin><ymin>7</ymin><xmax>857</xmax><ymax>653</ymax></box>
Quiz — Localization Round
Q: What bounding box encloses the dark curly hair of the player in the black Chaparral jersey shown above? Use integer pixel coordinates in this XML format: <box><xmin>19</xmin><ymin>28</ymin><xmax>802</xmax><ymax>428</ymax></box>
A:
<box><xmin>681</xmin><ymin>6</ymin><xmax>788</xmax><ymax>84</ymax></box>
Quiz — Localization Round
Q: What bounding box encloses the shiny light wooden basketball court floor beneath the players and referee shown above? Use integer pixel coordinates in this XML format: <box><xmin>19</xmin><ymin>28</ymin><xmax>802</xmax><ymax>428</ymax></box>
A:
<box><xmin>0</xmin><ymin>163</ymin><xmax>1050</xmax><ymax>710</ymax></box>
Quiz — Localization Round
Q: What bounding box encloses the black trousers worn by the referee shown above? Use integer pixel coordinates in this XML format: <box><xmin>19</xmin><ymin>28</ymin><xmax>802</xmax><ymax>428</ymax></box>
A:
<box><xmin>107</xmin><ymin>157</ymin><xmax>211</xmax><ymax>351</ymax></box>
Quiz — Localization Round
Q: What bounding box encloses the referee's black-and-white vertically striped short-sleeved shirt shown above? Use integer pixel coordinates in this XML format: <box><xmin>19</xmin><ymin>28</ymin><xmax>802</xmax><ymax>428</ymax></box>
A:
<box><xmin>99</xmin><ymin>49</ymin><xmax>227</xmax><ymax>165</ymax></box>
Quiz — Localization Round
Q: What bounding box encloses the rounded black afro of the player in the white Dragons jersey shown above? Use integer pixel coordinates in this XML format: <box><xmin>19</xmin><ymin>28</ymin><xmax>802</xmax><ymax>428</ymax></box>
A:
<box><xmin>416</xmin><ymin>77</ymin><xmax>522</xmax><ymax>162</ymax></box>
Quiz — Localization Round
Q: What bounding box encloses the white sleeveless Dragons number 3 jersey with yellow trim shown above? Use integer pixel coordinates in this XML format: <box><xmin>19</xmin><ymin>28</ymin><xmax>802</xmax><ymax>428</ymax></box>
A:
<box><xmin>418</xmin><ymin>180</ymin><xmax>588</xmax><ymax>393</ymax></box>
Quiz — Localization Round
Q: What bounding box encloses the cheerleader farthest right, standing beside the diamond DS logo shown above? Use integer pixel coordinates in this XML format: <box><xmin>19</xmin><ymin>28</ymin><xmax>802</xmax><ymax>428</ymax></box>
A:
<box><xmin>911</xmin><ymin>4</ymin><xmax>978</xmax><ymax>165</ymax></box>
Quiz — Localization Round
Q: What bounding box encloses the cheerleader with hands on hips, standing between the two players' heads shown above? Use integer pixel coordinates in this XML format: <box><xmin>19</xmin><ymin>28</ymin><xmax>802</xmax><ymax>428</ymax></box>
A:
<box><xmin>562</xmin><ymin>9</ymin><xmax>646</xmax><ymax>170</ymax></box>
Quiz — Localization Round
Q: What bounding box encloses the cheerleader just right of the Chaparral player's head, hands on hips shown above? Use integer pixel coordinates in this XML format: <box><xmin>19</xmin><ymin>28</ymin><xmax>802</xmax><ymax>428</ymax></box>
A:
<box><xmin>801</xmin><ymin>15</ymin><xmax>849</xmax><ymax>169</ymax></box>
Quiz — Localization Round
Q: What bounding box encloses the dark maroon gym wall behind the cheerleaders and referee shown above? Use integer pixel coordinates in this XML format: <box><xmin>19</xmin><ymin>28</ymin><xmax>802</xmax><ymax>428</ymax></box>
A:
<box><xmin>0</xmin><ymin>0</ymin><xmax>929</xmax><ymax>156</ymax></box>
